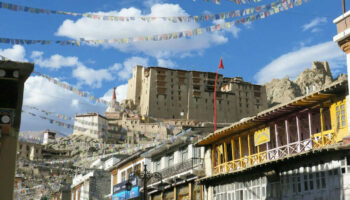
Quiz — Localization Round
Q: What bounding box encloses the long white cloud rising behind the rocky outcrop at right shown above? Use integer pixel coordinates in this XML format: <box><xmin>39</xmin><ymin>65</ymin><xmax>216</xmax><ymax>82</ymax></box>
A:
<box><xmin>254</xmin><ymin>41</ymin><xmax>346</xmax><ymax>83</ymax></box>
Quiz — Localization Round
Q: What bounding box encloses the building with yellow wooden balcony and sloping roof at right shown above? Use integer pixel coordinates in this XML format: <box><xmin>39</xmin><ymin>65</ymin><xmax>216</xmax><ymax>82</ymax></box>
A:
<box><xmin>196</xmin><ymin>80</ymin><xmax>350</xmax><ymax>200</ymax></box>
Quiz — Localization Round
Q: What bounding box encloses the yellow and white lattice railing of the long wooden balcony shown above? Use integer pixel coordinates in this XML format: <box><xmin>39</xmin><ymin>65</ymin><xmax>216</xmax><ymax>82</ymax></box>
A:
<box><xmin>213</xmin><ymin>130</ymin><xmax>337</xmax><ymax>174</ymax></box>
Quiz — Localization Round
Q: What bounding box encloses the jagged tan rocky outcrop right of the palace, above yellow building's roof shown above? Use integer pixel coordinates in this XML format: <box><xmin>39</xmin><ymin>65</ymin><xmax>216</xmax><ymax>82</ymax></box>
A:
<box><xmin>264</xmin><ymin>61</ymin><xmax>347</xmax><ymax>107</ymax></box>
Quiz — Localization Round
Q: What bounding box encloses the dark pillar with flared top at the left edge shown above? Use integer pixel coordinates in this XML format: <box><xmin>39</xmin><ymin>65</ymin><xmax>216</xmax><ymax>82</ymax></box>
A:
<box><xmin>0</xmin><ymin>60</ymin><xmax>34</xmax><ymax>200</ymax></box>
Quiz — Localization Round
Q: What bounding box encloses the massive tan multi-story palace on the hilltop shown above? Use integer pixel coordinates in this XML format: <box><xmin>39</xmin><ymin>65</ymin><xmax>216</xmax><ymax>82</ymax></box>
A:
<box><xmin>127</xmin><ymin>66</ymin><xmax>267</xmax><ymax>123</ymax></box>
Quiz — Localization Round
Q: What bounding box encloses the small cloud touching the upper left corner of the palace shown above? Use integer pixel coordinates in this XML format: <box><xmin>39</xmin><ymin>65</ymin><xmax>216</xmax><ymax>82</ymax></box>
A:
<box><xmin>117</xmin><ymin>56</ymin><xmax>148</xmax><ymax>80</ymax></box>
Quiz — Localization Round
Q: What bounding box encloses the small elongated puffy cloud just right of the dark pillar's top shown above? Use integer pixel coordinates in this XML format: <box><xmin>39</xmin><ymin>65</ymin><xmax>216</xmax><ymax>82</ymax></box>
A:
<box><xmin>30</xmin><ymin>51</ymin><xmax>79</xmax><ymax>69</ymax></box>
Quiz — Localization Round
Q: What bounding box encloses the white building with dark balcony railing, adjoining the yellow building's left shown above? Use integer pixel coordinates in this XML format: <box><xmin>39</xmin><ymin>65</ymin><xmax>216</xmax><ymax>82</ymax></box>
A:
<box><xmin>142</xmin><ymin>128</ymin><xmax>211</xmax><ymax>200</ymax></box>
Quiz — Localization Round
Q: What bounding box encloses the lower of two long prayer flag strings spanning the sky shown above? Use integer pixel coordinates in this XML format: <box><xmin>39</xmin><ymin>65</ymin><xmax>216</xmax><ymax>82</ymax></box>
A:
<box><xmin>0</xmin><ymin>0</ymin><xmax>311</xmax><ymax>47</ymax></box>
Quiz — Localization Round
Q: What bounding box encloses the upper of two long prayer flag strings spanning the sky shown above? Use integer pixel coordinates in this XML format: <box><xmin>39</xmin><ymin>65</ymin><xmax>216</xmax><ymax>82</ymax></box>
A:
<box><xmin>0</xmin><ymin>0</ymin><xmax>284</xmax><ymax>23</ymax></box>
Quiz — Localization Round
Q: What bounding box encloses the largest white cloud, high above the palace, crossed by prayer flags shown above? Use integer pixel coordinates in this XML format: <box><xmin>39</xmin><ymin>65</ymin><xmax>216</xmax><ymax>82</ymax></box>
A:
<box><xmin>56</xmin><ymin>4</ymin><xmax>230</xmax><ymax>58</ymax></box>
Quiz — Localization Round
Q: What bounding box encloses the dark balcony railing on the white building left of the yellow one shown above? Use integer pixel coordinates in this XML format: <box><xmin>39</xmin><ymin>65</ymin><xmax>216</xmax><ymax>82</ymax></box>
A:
<box><xmin>149</xmin><ymin>158</ymin><xmax>203</xmax><ymax>184</ymax></box>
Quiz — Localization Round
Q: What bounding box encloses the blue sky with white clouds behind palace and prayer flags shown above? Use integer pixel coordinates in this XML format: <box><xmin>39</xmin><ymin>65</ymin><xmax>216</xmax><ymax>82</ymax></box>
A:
<box><xmin>0</xmin><ymin>0</ymin><xmax>346</xmax><ymax>133</ymax></box>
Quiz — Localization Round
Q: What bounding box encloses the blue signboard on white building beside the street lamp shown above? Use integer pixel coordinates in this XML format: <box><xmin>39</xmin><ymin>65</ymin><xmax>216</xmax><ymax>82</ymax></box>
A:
<box><xmin>112</xmin><ymin>177</ymin><xmax>140</xmax><ymax>200</ymax></box>
